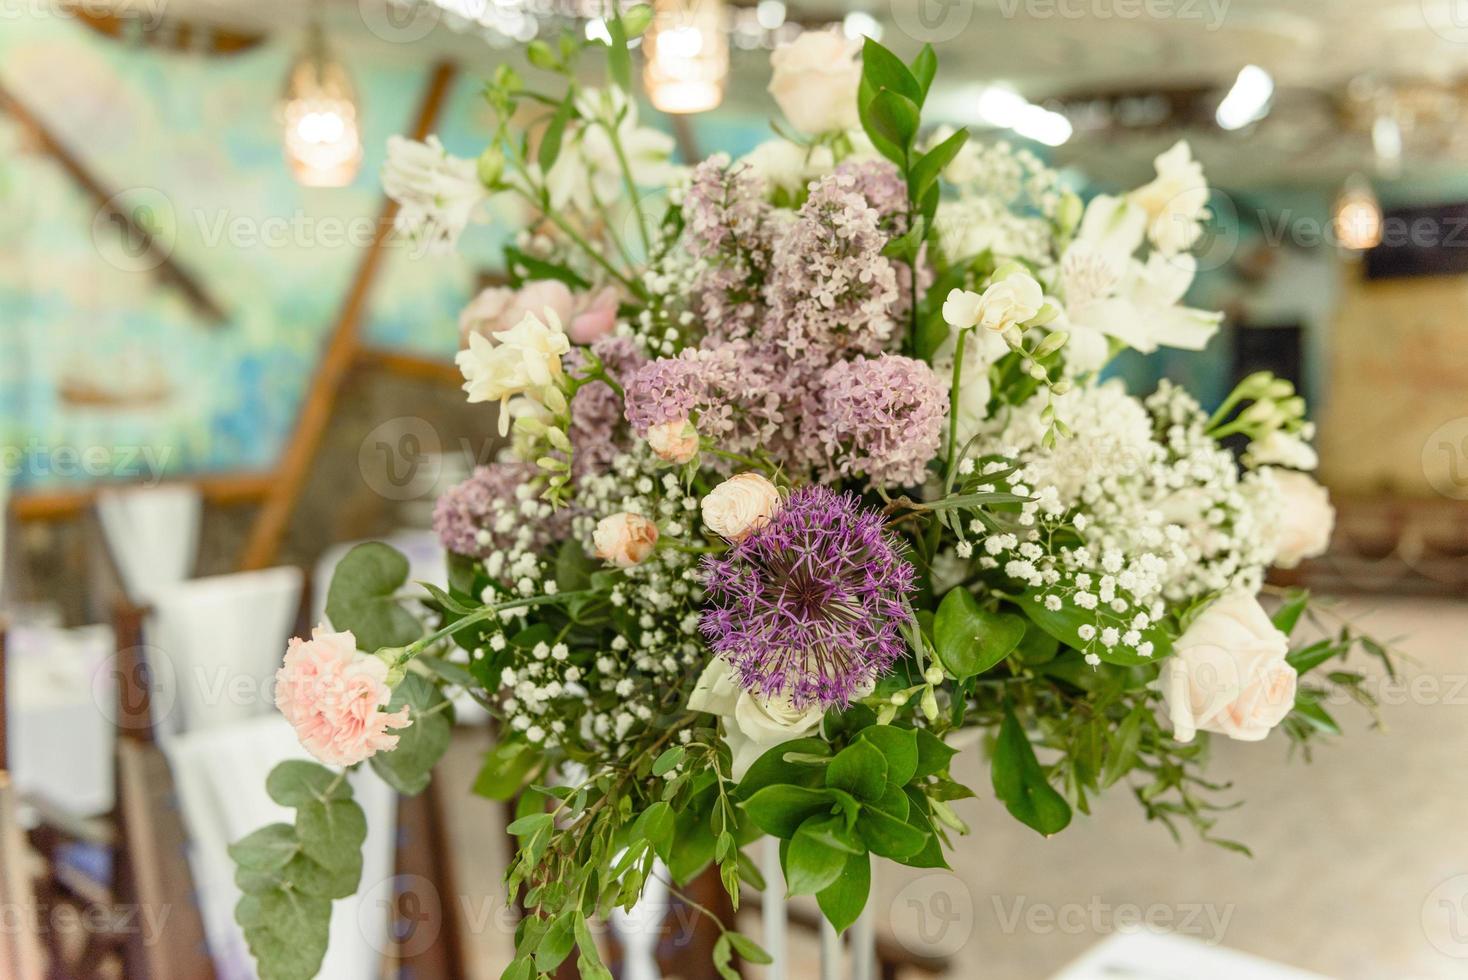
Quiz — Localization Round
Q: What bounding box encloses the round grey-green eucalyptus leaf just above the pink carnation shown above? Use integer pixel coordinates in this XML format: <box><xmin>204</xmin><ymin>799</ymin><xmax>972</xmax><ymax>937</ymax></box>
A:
<box><xmin>326</xmin><ymin>541</ymin><xmax>423</xmax><ymax>653</ymax></box>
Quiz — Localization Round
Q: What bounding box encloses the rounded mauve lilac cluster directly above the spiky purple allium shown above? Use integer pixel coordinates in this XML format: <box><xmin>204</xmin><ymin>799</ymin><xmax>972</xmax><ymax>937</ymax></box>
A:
<box><xmin>809</xmin><ymin>354</ymin><xmax>948</xmax><ymax>486</ymax></box>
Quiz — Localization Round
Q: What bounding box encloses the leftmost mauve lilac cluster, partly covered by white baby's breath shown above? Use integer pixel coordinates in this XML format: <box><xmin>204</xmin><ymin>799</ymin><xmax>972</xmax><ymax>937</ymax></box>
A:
<box><xmin>433</xmin><ymin>462</ymin><xmax>571</xmax><ymax>557</ymax></box>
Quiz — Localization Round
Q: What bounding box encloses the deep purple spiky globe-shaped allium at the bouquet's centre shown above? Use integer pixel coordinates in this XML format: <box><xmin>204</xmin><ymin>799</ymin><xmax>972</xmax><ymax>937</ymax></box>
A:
<box><xmin>699</xmin><ymin>486</ymin><xmax>915</xmax><ymax>707</ymax></box>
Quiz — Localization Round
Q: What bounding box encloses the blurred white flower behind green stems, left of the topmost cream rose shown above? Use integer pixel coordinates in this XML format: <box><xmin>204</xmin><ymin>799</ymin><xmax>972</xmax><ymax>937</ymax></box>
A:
<box><xmin>545</xmin><ymin>88</ymin><xmax>678</xmax><ymax>214</ymax></box>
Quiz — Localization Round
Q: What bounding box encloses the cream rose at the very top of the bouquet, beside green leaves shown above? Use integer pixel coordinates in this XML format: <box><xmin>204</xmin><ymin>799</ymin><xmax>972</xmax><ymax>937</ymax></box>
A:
<box><xmin>769</xmin><ymin>31</ymin><xmax>862</xmax><ymax>135</ymax></box>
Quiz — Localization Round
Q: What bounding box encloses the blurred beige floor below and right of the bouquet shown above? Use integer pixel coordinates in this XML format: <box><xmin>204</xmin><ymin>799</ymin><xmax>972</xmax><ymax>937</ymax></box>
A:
<box><xmin>449</xmin><ymin>600</ymin><xmax>1468</xmax><ymax>980</ymax></box>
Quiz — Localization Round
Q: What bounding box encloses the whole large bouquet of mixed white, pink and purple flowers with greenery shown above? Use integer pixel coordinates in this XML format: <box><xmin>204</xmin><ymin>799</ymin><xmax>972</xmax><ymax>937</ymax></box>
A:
<box><xmin>232</xmin><ymin>15</ymin><xmax>1387</xmax><ymax>979</ymax></box>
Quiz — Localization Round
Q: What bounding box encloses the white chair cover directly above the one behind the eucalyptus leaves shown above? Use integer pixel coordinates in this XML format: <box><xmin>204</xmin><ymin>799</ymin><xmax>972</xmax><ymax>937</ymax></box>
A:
<box><xmin>144</xmin><ymin>568</ymin><xmax>302</xmax><ymax>732</ymax></box>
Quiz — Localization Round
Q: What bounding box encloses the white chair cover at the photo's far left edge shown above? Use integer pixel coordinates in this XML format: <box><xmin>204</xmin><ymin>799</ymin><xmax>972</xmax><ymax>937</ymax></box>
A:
<box><xmin>6</xmin><ymin>626</ymin><xmax>116</xmax><ymax>816</ymax></box>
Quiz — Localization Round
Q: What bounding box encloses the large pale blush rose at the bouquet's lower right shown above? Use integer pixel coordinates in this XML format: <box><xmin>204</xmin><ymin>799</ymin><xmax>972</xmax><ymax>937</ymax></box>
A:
<box><xmin>1160</xmin><ymin>593</ymin><xmax>1296</xmax><ymax>742</ymax></box>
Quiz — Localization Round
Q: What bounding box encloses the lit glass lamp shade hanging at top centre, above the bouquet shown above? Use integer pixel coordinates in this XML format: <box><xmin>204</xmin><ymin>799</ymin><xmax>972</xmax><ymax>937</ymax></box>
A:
<box><xmin>643</xmin><ymin>0</ymin><xmax>730</xmax><ymax>114</ymax></box>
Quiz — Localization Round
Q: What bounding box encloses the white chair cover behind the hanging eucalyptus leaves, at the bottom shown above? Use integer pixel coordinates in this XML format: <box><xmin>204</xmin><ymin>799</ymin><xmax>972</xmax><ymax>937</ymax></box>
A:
<box><xmin>163</xmin><ymin>714</ymin><xmax>396</xmax><ymax>980</ymax></box>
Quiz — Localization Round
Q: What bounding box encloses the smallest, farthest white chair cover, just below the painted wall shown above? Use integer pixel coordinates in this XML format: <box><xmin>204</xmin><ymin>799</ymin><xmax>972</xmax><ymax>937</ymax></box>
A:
<box><xmin>97</xmin><ymin>484</ymin><xmax>203</xmax><ymax>604</ymax></box>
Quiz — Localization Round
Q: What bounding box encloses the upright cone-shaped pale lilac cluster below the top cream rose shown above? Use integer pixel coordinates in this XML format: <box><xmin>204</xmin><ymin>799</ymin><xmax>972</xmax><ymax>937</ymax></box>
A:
<box><xmin>760</xmin><ymin>172</ymin><xmax>898</xmax><ymax>368</ymax></box>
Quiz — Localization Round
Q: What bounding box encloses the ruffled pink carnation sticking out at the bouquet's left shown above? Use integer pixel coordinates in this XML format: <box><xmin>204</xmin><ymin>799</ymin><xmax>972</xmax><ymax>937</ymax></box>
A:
<box><xmin>276</xmin><ymin>626</ymin><xmax>411</xmax><ymax>766</ymax></box>
